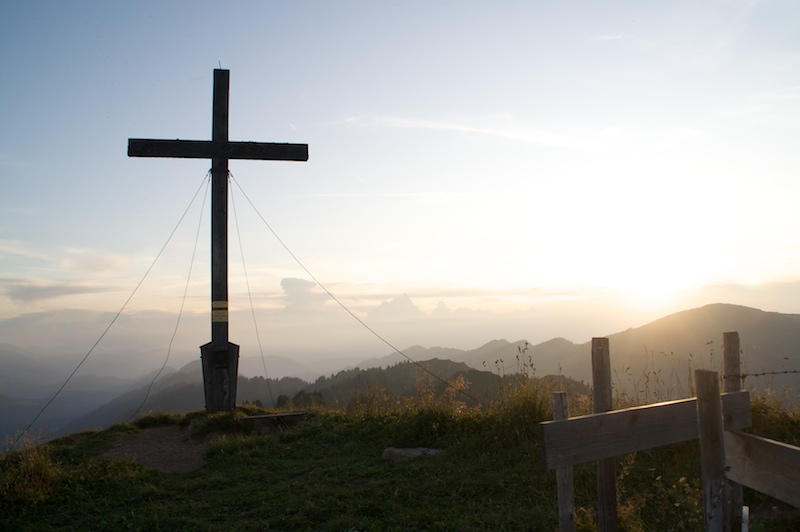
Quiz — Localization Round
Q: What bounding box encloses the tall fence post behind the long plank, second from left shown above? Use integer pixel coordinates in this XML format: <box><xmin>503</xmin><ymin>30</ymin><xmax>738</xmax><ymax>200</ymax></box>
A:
<box><xmin>592</xmin><ymin>338</ymin><xmax>617</xmax><ymax>532</ymax></box>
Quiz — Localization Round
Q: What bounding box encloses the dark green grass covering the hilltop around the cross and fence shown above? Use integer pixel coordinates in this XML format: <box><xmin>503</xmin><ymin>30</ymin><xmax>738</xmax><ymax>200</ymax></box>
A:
<box><xmin>0</xmin><ymin>383</ymin><xmax>800</xmax><ymax>531</ymax></box>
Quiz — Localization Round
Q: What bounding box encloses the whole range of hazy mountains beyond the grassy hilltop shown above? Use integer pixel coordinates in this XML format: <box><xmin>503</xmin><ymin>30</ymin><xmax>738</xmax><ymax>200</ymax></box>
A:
<box><xmin>0</xmin><ymin>304</ymin><xmax>800</xmax><ymax>444</ymax></box>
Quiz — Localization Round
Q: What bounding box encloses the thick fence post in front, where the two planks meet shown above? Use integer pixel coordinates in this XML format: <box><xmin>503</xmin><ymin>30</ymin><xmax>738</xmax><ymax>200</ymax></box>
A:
<box><xmin>694</xmin><ymin>369</ymin><xmax>731</xmax><ymax>532</ymax></box>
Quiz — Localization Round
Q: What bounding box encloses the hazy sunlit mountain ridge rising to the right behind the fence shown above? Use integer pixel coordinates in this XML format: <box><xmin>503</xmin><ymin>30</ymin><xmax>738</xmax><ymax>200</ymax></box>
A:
<box><xmin>356</xmin><ymin>303</ymin><xmax>800</xmax><ymax>400</ymax></box>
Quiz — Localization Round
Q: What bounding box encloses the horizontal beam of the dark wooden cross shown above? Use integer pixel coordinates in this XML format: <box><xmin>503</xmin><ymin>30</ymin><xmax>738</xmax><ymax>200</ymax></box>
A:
<box><xmin>128</xmin><ymin>139</ymin><xmax>308</xmax><ymax>161</ymax></box>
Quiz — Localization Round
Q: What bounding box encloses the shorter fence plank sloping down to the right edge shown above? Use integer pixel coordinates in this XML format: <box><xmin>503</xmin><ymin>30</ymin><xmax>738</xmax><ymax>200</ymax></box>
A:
<box><xmin>724</xmin><ymin>432</ymin><xmax>800</xmax><ymax>508</ymax></box>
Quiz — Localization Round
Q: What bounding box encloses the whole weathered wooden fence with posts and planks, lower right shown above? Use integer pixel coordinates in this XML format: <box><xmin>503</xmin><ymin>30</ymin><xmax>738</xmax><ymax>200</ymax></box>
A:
<box><xmin>541</xmin><ymin>332</ymin><xmax>800</xmax><ymax>531</ymax></box>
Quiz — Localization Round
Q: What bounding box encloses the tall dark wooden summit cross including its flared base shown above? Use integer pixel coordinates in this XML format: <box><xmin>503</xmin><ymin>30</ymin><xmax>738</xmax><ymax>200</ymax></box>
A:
<box><xmin>128</xmin><ymin>69</ymin><xmax>308</xmax><ymax>412</ymax></box>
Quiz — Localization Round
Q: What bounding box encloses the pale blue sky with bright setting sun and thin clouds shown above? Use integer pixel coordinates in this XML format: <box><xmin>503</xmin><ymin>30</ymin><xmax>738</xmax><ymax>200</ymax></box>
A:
<box><xmin>0</xmin><ymin>0</ymin><xmax>800</xmax><ymax>373</ymax></box>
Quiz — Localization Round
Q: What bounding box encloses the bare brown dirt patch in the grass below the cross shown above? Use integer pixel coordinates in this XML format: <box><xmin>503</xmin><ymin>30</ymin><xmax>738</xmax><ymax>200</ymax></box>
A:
<box><xmin>103</xmin><ymin>425</ymin><xmax>211</xmax><ymax>473</ymax></box>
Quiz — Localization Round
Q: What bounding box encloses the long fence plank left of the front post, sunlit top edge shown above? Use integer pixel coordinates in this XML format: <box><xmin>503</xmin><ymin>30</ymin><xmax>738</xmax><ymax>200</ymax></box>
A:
<box><xmin>540</xmin><ymin>391</ymin><xmax>752</xmax><ymax>469</ymax></box>
